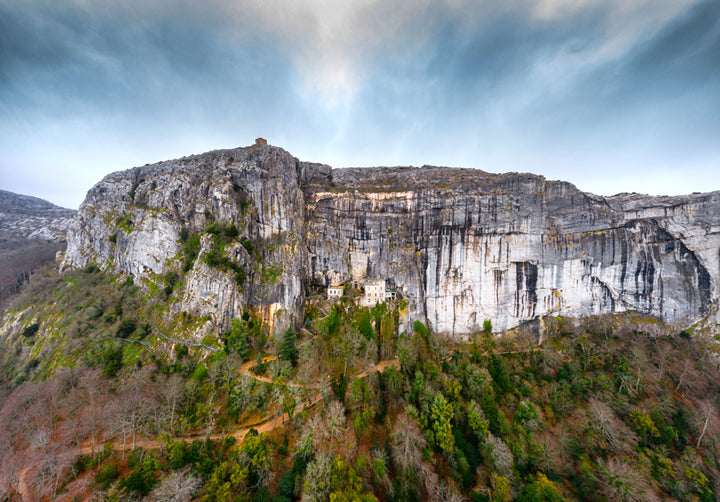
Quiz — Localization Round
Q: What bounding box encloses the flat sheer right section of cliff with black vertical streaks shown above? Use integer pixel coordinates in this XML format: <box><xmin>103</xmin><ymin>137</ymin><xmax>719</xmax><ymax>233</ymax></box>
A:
<box><xmin>306</xmin><ymin>167</ymin><xmax>720</xmax><ymax>336</ymax></box>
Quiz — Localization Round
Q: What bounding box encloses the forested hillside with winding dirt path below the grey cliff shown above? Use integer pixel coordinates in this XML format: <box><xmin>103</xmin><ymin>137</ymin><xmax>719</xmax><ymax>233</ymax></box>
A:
<box><xmin>0</xmin><ymin>266</ymin><xmax>720</xmax><ymax>501</ymax></box>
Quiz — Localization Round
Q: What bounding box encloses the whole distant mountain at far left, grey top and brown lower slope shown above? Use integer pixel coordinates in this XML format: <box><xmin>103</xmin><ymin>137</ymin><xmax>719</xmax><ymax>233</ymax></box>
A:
<box><xmin>0</xmin><ymin>190</ymin><xmax>76</xmax><ymax>307</ymax></box>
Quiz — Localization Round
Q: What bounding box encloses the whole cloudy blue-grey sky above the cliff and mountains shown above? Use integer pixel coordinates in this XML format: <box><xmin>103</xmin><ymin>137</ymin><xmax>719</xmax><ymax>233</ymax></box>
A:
<box><xmin>0</xmin><ymin>0</ymin><xmax>720</xmax><ymax>208</ymax></box>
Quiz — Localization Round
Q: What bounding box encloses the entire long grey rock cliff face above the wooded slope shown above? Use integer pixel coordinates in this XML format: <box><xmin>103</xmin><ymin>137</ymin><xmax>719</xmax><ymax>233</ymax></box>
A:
<box><xmin>63</xmin><ymin>145</ymin><xmax>720</xmax><ymax>337</ymax></box>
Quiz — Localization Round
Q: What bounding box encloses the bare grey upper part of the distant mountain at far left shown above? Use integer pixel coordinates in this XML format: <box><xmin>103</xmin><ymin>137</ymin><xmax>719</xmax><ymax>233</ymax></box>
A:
<box><xmin>0</xmin><ymin>190</ymin><xmax>76</xmax><ymax>242</ymax></box>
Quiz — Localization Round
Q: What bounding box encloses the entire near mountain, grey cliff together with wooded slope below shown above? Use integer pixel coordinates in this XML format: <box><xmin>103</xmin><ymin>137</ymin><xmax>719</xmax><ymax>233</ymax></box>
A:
<box><xmin>0</xmin><ymin>145</ymin><xmax>720</xmax><ymax>502</ymax></box>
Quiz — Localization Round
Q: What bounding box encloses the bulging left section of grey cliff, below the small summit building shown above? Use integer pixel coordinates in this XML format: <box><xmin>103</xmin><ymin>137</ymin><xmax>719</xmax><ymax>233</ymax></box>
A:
<box><xmin>62</xmin><ymin>146</ymin><xmax>318</xmax><ymax>334</ymax></box>
